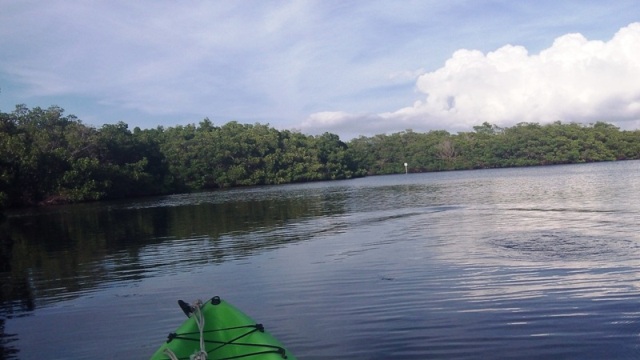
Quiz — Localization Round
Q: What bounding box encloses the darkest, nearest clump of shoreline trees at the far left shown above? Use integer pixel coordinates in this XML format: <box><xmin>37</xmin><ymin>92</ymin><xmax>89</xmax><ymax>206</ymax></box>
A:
<box><xmin>0</xmin><ymin>105</ymin><xmax>172</xmax><ymax>206</ymax></box>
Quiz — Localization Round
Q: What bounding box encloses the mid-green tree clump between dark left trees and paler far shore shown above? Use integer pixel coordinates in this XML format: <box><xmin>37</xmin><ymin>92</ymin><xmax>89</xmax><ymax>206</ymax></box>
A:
<box><xmin>162</xmin><ymin>121</ymin><xmax>355</xmax><ymax>190</ymax></box>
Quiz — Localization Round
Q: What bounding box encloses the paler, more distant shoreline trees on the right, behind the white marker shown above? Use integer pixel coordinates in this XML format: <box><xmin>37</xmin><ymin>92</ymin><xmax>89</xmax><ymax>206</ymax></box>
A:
<box><xmin>348</xmin><ymin>121</ymin><xmax>640</xmax><ymax>175</ymax></box>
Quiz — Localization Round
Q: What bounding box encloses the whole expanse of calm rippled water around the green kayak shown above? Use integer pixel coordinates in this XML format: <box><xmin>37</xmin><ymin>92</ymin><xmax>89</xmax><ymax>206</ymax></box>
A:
<box><xmin>0</xmin><ymin>161</ymin><xmax>640</xmax><ymax>359</ymax></box>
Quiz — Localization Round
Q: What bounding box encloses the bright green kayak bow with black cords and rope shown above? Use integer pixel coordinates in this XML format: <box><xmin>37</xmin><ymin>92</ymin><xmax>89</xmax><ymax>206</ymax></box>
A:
<box><xmin>151</xmin><ymin>296</ymin><xmax>295</xmax><ymax>360</ymax></box>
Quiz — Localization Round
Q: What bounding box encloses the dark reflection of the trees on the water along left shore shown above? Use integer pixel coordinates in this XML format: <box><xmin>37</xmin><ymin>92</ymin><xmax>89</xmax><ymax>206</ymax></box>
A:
<box><xmin>2</xmin><ymin>190</ymin><xmax>343</xmax><ymax>310</ymax></box>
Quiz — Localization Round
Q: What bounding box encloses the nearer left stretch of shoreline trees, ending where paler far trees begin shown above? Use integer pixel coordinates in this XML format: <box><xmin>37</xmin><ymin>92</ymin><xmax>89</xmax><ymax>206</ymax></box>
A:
<box><xmin>0</xmin><ymin>105</ymin><xmax>364</xmax><ymax>207</ymax></box>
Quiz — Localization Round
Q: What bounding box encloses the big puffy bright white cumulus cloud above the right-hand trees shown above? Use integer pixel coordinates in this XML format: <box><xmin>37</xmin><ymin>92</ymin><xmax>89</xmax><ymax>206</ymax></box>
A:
<box><xmin>303</xmin><ymin>23</ymin><xmax>640</xmax><ymax>138</ymax></box>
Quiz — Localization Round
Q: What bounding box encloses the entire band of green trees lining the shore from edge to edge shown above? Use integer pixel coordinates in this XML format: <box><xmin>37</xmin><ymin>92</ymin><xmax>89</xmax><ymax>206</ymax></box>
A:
<box><xmin>0</xmin><ymin>105</ymin><xmax>640</xmax><ymax>208</ymax></box>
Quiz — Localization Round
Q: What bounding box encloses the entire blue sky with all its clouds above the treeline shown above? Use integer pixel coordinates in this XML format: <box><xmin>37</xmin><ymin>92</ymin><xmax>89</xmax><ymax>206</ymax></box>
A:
<box><xmin>0</xmin><ymin>0</ymin><xmax>640</xmax><ymax>140</ymax></box>
